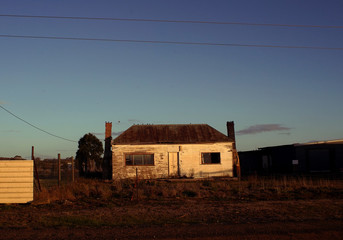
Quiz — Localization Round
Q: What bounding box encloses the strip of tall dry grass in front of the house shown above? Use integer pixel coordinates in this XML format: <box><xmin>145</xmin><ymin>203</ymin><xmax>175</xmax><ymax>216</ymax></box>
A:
<box><xmin>35</xmin><ymin>176</ymin><xmax>343</xmax><ymax>204</ymax></box>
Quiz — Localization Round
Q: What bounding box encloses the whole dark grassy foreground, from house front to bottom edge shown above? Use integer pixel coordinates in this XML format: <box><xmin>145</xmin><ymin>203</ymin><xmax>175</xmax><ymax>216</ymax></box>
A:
<box><xmin>0</xmin><ymin>177</ymin><xmax>343</xmax><ymax>240</ymax></box>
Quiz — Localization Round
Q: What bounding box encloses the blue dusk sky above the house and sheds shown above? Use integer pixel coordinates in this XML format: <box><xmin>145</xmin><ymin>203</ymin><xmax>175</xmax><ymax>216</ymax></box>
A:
<box><xmin>0</xmin><ymin>0</ymin><xmax>343</xmax><ymax>158</ymax></box>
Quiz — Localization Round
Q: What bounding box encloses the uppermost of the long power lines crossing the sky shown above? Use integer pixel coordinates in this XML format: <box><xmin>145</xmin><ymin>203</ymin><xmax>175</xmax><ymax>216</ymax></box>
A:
<box><xmin>0</xmin><ymin>14</ymin><xmax>343</xmax><ymax>29</ymax></box>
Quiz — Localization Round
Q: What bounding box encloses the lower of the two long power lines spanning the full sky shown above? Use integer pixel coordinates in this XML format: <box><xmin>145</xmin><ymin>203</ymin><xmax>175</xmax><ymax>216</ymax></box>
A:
<box><xmin>0</xmin><ymin>34</ymin><xmax>343</xmax><ymax>50</ymax></box>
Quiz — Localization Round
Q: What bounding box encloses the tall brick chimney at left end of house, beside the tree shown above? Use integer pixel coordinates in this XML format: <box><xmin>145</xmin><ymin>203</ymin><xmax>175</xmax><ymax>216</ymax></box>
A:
<box><xmin>102</xmin><ymin>122</ymin><xmax>112</xmax><ymax>179</ymax></box>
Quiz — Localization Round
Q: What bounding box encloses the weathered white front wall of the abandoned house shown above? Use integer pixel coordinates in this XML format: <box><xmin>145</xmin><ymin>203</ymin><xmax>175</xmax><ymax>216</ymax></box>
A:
<box><xmin>112</xmin><ymin>142</ymin><xmax>233</xmax><ymax>179</ymax></box>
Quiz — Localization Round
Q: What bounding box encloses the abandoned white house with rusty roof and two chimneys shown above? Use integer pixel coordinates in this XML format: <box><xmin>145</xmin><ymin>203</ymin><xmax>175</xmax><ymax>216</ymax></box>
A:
<box><xmin>104</xmin><ymin>122</ymin><xmax>236</xmax><ymax>179</ymax></box>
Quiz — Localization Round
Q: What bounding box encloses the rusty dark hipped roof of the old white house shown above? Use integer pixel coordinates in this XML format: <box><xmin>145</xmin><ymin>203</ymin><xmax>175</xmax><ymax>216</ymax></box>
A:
<box><xmin>112</xmin><ymin>124</ymin><xmax>233</xmax><ymax>144</ymax></box>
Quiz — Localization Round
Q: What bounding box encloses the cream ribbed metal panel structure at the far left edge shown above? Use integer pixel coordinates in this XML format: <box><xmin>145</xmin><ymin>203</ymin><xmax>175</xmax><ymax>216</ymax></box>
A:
<box><xmin>0</xmin><ymin>160</ymin><xmax>33</xmax><ymax>203</ymax></box>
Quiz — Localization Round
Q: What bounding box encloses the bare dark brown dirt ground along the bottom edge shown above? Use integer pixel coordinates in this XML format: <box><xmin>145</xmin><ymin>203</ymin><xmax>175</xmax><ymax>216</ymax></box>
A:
<box><xmin>0</xmin><ymin>198</ymin><xmax>343</xmax><ymax>240</ymax></box>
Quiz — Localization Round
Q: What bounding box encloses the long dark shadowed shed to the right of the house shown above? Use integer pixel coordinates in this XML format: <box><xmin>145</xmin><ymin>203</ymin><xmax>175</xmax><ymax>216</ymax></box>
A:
<box><xmin>239</xmin><ymin>139</ymin><xmax>343</xmax><ymax>174</ymax></box>
